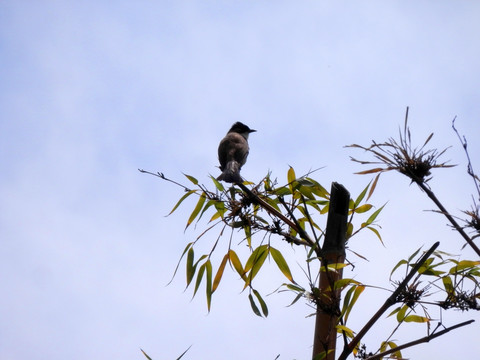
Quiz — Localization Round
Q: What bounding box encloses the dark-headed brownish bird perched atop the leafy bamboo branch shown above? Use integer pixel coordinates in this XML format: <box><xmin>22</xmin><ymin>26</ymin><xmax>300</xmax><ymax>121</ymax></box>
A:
<box><xmin>217</xmin><ymin>122</ymin><xmax>257</xmax><ymax>183</ymax></box>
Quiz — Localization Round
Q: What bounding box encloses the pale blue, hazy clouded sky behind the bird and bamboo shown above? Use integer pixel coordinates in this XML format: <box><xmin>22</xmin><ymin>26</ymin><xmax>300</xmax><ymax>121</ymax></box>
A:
<box><xmin>0</xmin><ymin>0</ymin><xmax>480</xmax><ymax>360</ymax></box>
